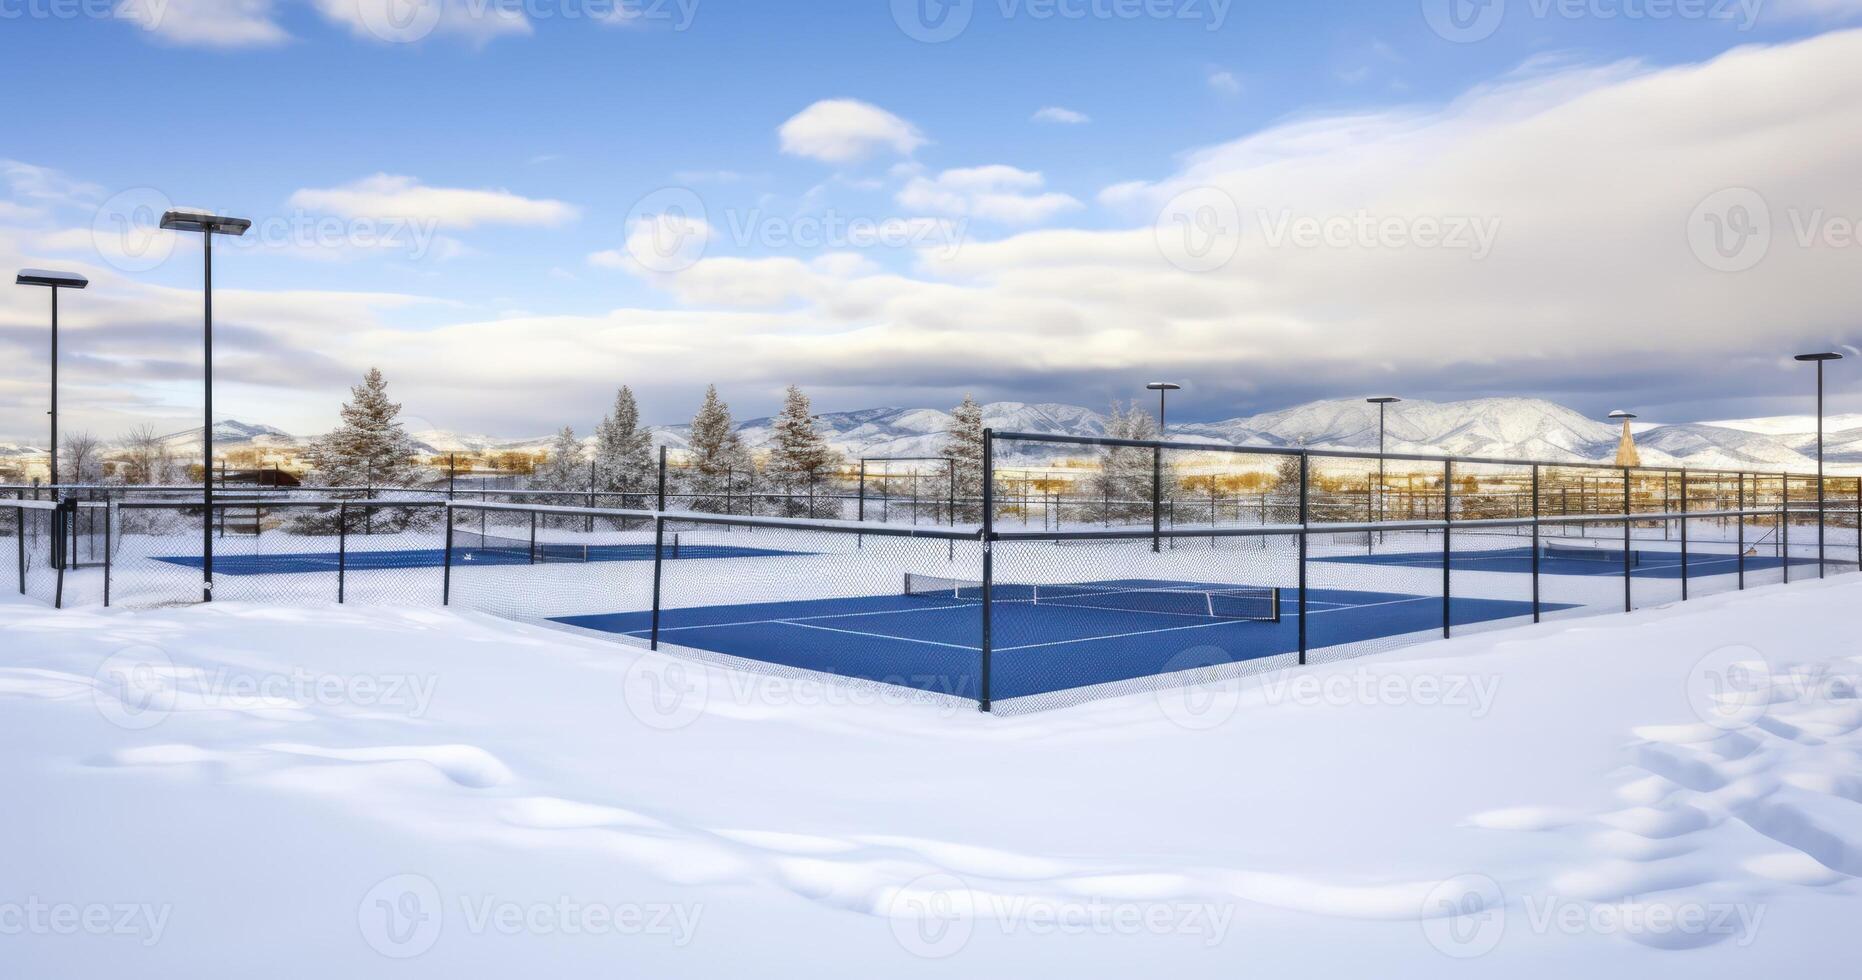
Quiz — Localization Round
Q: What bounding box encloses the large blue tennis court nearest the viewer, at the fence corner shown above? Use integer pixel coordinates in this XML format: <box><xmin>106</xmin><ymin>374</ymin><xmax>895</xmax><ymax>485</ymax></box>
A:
<box><xmin>557</xmin><ymin>579</ymin><xmax>1568</xmax><ymax>699</ymax></box>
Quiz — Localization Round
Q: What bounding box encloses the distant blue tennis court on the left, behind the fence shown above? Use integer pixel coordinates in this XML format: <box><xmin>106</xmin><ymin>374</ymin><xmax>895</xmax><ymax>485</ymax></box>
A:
<box><xmin>155</xmin><ymin>542</ymin><xmax>806</xmax><ymax>576</ymax></box>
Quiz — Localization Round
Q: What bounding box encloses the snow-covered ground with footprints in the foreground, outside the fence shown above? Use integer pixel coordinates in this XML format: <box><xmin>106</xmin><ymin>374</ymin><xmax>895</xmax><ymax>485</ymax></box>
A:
<box><xmin>0</xmin><ymin>576</ymin><xmax>1862</xmax><ymax>978</ymax></box>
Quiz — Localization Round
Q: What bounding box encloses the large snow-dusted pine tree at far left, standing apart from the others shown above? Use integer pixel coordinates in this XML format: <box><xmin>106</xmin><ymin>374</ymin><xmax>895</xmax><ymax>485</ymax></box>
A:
<box><xmin>296</xmin><ymin>367</ymin><xmax>430</xmax><ymax>533</ymax></box>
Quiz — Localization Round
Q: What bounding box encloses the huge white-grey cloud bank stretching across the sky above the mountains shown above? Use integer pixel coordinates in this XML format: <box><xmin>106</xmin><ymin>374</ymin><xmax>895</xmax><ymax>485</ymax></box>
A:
<box><xmin>0</xmin><ymin>32</ymin><xmax>1862</xmax><ymax>434</ymax></box>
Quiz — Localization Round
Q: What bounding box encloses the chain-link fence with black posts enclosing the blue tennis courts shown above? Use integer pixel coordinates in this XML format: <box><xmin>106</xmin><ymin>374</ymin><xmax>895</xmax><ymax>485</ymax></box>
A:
<box><xmin>0</xmin><ymin>432</ymin><xmax>1862</xmax><ymax>710</ymax></box>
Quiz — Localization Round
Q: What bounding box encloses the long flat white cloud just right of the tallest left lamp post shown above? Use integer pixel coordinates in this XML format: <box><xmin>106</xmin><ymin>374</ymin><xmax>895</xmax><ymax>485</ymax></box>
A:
<box><xmin>290</xmin><ymin>173</ymin><xmax>577</xmax><ymax>229</ymax></box>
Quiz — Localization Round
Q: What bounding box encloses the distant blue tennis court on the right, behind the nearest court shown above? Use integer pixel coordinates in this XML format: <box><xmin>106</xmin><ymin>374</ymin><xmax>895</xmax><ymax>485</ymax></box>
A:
<box><xmin>1313</xmin><ymin>544</ymin><xmax>1817</xmax><ymax>579</ymax></box>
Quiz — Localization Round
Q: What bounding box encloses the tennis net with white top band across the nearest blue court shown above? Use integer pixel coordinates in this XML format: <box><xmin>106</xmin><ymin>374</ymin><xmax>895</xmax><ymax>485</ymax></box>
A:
<box><xmin>905</xmin><ymin>572</ymin><xmax>1281</xmax><ymax>622</ymax></box>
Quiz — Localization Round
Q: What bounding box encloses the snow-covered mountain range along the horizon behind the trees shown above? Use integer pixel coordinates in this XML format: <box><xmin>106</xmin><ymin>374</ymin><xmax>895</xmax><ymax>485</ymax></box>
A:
<box><xmin>0</xmin><ymin>399</ymin><xmax>1862</xmax><ymax>470</ymax></box>
